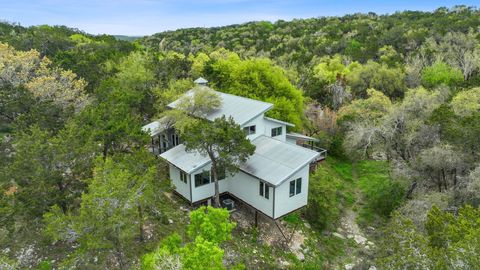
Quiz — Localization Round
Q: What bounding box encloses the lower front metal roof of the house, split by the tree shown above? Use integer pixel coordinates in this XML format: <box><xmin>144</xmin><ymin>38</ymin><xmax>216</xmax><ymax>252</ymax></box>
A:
<box><xmin>160</xmin><ymin>136</ymin><xmax>319</xmax><ymax>186</ymax></box>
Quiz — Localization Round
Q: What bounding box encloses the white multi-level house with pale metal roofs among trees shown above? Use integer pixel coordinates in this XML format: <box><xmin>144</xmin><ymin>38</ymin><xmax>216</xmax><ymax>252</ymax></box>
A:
<box><xmin>143</xmin><ymin>79</ymin><xmax>325</xmax><ymax>219</ymax></box>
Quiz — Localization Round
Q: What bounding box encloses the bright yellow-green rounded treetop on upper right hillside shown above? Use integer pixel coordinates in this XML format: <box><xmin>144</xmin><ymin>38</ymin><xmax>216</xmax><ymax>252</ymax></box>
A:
<box><xmin>422</xmin><ymin>62</ymin><xmax>463</xmax><ymax>88</ymax></box>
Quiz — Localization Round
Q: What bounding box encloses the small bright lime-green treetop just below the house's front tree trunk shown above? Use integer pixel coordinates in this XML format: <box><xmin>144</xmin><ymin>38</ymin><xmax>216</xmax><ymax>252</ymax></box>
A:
<box><xmin>188</xmin><ymin>206</ymin><xmax>235</xmax><ymax>244</ymax></box>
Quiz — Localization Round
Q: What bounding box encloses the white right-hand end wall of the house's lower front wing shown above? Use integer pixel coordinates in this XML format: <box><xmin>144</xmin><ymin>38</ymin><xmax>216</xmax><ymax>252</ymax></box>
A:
<box><xmin>274</xmin><ymin>164</ymin><xmax>309</xmax><ymax>219</ymax></box>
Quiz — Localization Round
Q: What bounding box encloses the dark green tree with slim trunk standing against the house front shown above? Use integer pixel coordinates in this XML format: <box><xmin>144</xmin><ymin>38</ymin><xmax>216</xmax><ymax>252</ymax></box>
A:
<box><xmin>183</xmin><ymin>116</ymin><xmax>255</xmax><ymax>207</ymax></box>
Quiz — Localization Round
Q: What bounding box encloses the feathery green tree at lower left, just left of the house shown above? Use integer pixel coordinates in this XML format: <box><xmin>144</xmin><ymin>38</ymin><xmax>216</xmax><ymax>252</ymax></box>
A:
<box><xmin>44</xmin><ymin>153</ymin><xmax>160</xmax><ymax>269</ymax></box>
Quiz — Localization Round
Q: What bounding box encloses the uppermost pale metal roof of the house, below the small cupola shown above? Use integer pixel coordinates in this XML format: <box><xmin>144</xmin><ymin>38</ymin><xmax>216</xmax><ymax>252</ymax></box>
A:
<box><xmin>167</xmin><ymin>86</ymin><xmax>273</xmax><ymax>125</ymax></box>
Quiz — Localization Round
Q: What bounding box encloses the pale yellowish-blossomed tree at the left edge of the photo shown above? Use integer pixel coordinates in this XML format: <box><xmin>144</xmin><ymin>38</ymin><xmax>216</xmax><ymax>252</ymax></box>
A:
<box><xmin>0</xmin><ymin>43</ymin><xmax>89</xmax><ymax>131</ymax></box>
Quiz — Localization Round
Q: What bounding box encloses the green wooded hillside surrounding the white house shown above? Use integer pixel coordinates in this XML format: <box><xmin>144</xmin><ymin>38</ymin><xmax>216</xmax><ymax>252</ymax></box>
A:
<box><xmin>0</xmin><ymin>6</ymin><xmax>480</xmax><ymax>270</ymax></box>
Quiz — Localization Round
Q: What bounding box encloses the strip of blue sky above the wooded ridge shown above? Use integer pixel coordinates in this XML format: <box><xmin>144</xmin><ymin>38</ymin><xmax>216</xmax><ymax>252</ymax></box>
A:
<box><xmin>0</xmin><ymin>0</ymin><xmax>480</xmax><ymax>35</ymax></box>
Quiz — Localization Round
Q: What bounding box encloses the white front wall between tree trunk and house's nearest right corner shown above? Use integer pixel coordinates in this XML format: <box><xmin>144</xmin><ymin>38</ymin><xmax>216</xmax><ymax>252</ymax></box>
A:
<box><xmin>230</xmin><ymin>171</ymin><xmax>273</xmax><ymax>217</ymax></box>
